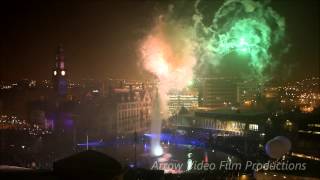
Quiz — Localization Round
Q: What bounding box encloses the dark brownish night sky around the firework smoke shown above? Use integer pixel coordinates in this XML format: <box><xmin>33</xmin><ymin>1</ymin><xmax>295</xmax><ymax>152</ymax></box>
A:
<box><xmin>0</xmin><ymin>0</ymin><xmax>319</xmax><ymax>81</ymax></box>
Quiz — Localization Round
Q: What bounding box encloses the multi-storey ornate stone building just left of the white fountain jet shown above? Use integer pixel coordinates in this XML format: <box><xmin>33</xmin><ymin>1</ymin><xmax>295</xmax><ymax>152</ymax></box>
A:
<box><xmin>102</xmin><ymin>85</ymin><xmax>152</xmax><ymax>135</ymax></box>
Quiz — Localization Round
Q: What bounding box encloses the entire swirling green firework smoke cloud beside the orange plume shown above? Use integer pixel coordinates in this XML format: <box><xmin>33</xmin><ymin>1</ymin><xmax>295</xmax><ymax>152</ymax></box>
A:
<box><xmin>193</xmin><ymin>0</ymin><xmax>287</xmax><ymax>80</ymax></box>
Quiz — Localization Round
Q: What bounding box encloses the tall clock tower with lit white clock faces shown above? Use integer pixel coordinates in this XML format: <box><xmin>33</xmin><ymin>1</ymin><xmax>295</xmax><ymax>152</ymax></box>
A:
<box><xmin>52</xmin><ymin>45</ymin><xmax>68</xmax><ymax>97</ymax></box>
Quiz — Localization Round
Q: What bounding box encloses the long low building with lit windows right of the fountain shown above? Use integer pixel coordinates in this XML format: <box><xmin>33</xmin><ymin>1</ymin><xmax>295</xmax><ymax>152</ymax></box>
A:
<box><xmin>176</xmin><ymin>109</ymin><xmax>267</xmax><ymax>135</ymax></box>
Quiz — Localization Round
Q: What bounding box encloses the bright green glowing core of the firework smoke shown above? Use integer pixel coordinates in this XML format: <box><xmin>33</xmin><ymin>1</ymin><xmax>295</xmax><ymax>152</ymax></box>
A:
<box><xmin>213</xmin><ymin>18</ymin><xmax>271</xmax><ymax>71</ymax></box>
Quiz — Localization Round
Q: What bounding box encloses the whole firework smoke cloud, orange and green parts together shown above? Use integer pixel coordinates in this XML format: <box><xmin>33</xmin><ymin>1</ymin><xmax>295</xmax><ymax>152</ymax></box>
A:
<box><xmin>139</xmin><ymin>0</ymin><xmax>289</xmax><ymax>115</ymax></box>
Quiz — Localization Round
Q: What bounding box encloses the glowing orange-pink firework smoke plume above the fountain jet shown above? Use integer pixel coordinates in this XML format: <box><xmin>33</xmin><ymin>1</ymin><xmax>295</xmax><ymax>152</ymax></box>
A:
<box><xmin>139</xmin><ymin>16</ymin><xmax>196</xmax><ymax>118</ymax></box>
